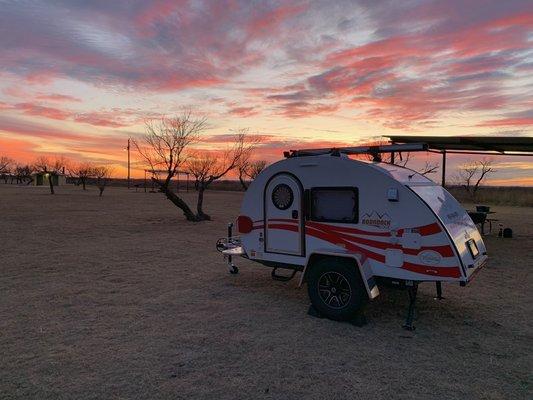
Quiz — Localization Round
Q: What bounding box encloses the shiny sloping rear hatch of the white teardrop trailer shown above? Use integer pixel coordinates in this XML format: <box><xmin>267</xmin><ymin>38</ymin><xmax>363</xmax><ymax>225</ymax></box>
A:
<box><xmin>409</xmin><ymin>184</ymin><xmax>487</xmax><ymax>281</ymax></box>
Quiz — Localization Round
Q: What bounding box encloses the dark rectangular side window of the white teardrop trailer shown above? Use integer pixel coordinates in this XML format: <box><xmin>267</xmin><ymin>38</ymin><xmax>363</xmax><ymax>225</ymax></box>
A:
<box><xmin>310</xmin><ymin>187</ymin><xmax>359</xmax><ymax>223</ymax></box>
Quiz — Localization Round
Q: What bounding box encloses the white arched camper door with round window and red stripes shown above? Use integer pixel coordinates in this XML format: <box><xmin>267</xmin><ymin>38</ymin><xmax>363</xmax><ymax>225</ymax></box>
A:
<box><xmin>264</xmin><ymin>173</ymin><xmax>304</xmax><ymax>256</ymax></box>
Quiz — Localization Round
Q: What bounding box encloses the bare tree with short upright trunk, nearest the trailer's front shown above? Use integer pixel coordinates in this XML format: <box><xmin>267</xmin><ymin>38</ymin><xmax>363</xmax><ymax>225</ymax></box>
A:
<box><xmin>187</xmin><ymin>131</ymin><xmax>253</xmax><ymax>220</ymax></box>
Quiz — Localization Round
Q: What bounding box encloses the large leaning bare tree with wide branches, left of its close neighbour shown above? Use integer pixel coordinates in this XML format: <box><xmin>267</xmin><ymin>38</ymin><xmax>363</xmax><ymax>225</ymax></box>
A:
<box><xmin>133</xmin><ymin>111</ymin><xmax>207</xmax><ymax>221</ymax></box>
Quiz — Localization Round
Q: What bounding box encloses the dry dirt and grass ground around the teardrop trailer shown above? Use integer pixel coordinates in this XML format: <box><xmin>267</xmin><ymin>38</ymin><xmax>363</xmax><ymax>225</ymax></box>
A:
<box><xmin>0</xmin><ymin>185</ymin><xmax>533</xmax><ymax>399</ymax></box>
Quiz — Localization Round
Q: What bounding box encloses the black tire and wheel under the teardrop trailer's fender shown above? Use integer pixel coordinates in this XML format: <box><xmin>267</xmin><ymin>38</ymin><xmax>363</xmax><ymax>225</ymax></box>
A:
<box><xmin>307</xmin><ymin>258</ymin><xmax>368</xmax><ymax>321</ymax></box>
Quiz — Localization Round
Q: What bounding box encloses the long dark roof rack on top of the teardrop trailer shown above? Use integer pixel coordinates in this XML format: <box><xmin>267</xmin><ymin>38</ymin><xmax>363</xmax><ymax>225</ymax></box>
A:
<box><xmin>283</xmin><ymin>143</ymin><xmax>428</xmax><ymax>161</ymax></box>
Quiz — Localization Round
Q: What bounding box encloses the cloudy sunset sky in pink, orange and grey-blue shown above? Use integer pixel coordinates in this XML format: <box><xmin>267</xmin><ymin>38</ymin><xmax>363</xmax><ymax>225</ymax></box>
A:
<box><xmin>0</xmin><ymin>0</ymin><xmax>533</xmax><ymax>185</ymax></box>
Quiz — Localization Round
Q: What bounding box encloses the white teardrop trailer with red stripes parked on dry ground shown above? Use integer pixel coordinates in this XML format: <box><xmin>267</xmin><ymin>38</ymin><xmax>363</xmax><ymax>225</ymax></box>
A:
<box><xmin>217</xmin><ymin>144</ymin><xmax>487</xmax><ymax>330</ymax></box>
